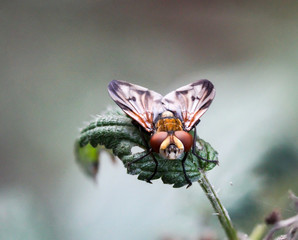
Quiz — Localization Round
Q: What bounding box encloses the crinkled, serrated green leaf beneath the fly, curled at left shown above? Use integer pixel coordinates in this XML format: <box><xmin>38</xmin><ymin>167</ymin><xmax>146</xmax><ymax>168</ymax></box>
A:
<box><xmin>75</xmin><ymin>110</ymin><xmax>218</xmax><ymax>188</ymax></box>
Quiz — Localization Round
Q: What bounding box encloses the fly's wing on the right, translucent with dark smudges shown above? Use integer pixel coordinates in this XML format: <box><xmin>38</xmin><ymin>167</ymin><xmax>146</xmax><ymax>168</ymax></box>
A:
<box><xmin>162</xmin><ymin>79</ymin><xmax>215</xmax><ymax>131</ymax></box>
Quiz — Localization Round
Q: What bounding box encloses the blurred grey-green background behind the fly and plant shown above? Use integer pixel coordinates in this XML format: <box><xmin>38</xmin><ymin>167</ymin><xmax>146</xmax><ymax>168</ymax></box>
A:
<box><xmin>0</xmin><ymin>0</ymin><xmax>298</xmax><ymax>240</ymax></box>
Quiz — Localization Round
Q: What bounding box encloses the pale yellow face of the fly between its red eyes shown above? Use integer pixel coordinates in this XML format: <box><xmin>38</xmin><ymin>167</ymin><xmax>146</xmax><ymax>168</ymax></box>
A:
<box><xmin>159</xmin><ymin>135</ymin><xmax>184</xmax><ymax>159</ymax></box>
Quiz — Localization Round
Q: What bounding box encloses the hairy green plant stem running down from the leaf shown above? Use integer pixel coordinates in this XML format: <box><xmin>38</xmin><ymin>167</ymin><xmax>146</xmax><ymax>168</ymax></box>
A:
<box><xmin>198</xmin><ymin>171</ymin><xmax>238</xmax><ymax>240</ymax></box>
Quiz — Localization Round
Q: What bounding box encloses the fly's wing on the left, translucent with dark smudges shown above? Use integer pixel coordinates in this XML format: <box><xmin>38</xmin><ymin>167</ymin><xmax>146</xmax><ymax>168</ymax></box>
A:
<box><xmin>108</xmin><ymin>80</ymin><xmax>163</xmax><ymax>132</ymax></box>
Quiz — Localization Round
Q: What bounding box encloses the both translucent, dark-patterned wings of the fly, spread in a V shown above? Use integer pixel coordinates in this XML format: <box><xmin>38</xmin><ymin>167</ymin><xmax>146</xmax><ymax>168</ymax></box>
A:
<box><xmin>108</xmin><ymin>79</ymin><xmax>215</xmax><ymax>132</ymax></box>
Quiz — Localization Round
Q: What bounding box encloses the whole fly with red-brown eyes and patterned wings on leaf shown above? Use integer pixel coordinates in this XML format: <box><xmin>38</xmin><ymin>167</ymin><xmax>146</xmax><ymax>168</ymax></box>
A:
<box><xmin>108</xmin><ymin>79</ymin><xmax>217</xmax><ymax>187</ymax></box>
